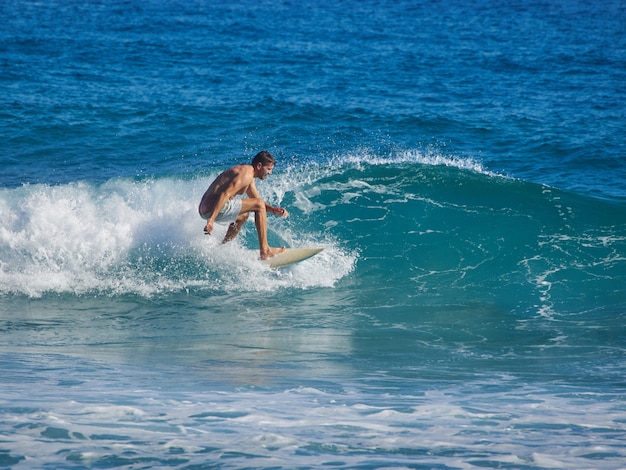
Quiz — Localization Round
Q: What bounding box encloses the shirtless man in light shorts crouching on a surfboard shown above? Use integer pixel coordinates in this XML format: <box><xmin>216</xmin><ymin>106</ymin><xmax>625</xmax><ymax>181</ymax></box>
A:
<box><xmin>198</xmin><ymin>151</ymin><xmax>289</xmax><ymax>259</ymax></box>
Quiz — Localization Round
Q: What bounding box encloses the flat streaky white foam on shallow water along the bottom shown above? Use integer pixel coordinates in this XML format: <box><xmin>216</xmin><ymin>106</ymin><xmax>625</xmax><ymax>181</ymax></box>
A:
<box><xmin>0</xmin><ymin>383</ymin><xmax>626</xmax><ymax>469</ymax></box>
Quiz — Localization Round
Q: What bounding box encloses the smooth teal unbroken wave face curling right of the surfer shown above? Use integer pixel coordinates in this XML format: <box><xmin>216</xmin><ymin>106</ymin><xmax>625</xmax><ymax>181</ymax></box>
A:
<box><xmin>290</xmin><ymin>152</ymin><xmax>626</xmax><ymax>319</ymax></box>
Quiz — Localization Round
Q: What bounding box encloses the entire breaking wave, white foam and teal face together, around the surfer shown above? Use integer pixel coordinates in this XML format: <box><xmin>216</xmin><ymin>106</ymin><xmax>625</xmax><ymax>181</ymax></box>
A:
<box><xmin>0</xmin><ymin>150</ymin><xmax>626</xmax><ymax>318</ymax></box>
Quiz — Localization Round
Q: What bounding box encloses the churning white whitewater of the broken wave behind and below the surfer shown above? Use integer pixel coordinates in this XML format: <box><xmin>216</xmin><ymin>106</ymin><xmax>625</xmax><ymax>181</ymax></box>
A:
<box><xmin>0</xmin><ymin>178</ymin><xmax>355</xmax><ymax>297</ymax></box>
